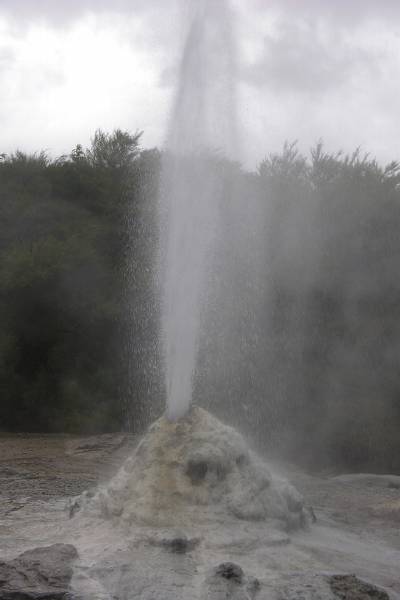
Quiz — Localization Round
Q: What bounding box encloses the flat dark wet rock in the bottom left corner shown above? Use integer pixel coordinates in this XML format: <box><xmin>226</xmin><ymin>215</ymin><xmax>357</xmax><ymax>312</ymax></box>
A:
<box><xmin>0</xmin><ymin>544</ymin><xmax>78</xmax><ymax>600</ymax></box>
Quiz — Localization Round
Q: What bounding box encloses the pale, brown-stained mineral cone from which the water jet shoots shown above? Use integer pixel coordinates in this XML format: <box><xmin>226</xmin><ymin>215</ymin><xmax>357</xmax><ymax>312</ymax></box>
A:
<box><xmin>72</xmin><ymin>407</ymin><xmax>305</xmax><ymax>529</ymax></box>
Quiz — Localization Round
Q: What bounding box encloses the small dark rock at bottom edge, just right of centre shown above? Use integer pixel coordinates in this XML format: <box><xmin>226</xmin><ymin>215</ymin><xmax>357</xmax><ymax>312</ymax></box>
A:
<box><xmin>202</xmin><ymin>562</ymin><xmax>260</xmax><ymax>600</ymax></box>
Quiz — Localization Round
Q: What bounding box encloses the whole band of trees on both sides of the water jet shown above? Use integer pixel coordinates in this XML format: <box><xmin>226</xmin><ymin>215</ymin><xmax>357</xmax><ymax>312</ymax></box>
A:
<box><xmin>0</xmin><ymin>131</ymin><xmax>400</xmax><ymax>471</ymax></box>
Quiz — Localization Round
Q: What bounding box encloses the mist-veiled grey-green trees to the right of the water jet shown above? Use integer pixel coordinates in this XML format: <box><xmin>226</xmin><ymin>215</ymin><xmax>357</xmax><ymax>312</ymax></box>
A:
<box><xmin>197</xmin><ymin>143</ymin><xmax>400</xmax><ymax>472</ymax></box>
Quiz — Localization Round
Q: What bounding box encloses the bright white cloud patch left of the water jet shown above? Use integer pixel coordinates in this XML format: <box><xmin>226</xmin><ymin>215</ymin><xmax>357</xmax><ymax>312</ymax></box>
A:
<box><xmin>0</xmin><ymin>16</ymin><xmax>169</xmax><ymax>154</ymax></box>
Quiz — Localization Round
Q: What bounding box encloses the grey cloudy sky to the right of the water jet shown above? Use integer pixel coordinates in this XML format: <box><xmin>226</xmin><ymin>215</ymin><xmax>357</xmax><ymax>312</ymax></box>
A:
<box><xmin>234</xmin><ymin>0</ymin><xmax>400</xmax><ymax>162</ymax></box>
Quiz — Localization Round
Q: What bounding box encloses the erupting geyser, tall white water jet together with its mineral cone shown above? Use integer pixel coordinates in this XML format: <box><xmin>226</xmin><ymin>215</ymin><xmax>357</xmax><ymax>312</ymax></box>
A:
<box><xmin>70</xmin><ymin>0</ymin><xmax>306</xmax><ymax>530</ymax></box>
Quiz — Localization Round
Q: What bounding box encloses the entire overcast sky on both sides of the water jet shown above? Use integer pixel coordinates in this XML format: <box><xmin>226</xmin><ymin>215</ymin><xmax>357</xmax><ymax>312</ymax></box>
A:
<box><xmin>0</xmin><ymin>0</ymin><xmax>400</xmax><ymax>167</ymax></box>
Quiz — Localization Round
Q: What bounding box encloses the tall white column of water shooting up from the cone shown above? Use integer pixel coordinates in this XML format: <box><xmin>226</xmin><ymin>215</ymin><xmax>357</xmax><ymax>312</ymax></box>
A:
<box><xmin>160</xmin><ymin>0</ymin><xmax>236</xmax><ymax>420</ymax></box>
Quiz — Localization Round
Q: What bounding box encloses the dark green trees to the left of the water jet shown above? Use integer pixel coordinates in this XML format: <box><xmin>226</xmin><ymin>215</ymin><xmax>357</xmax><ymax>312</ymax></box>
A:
<box><xmin>0</xmin><ymin>130</ymin><xmax>157</xmax><ymax>431</ymax></box>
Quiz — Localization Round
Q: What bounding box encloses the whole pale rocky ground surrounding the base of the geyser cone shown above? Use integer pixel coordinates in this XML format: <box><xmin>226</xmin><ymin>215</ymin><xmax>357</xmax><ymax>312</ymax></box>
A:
<box><xmin>0</xmin><ymin>434</ymin><xmax>400</xmax><ymax>600</ymax></box>
